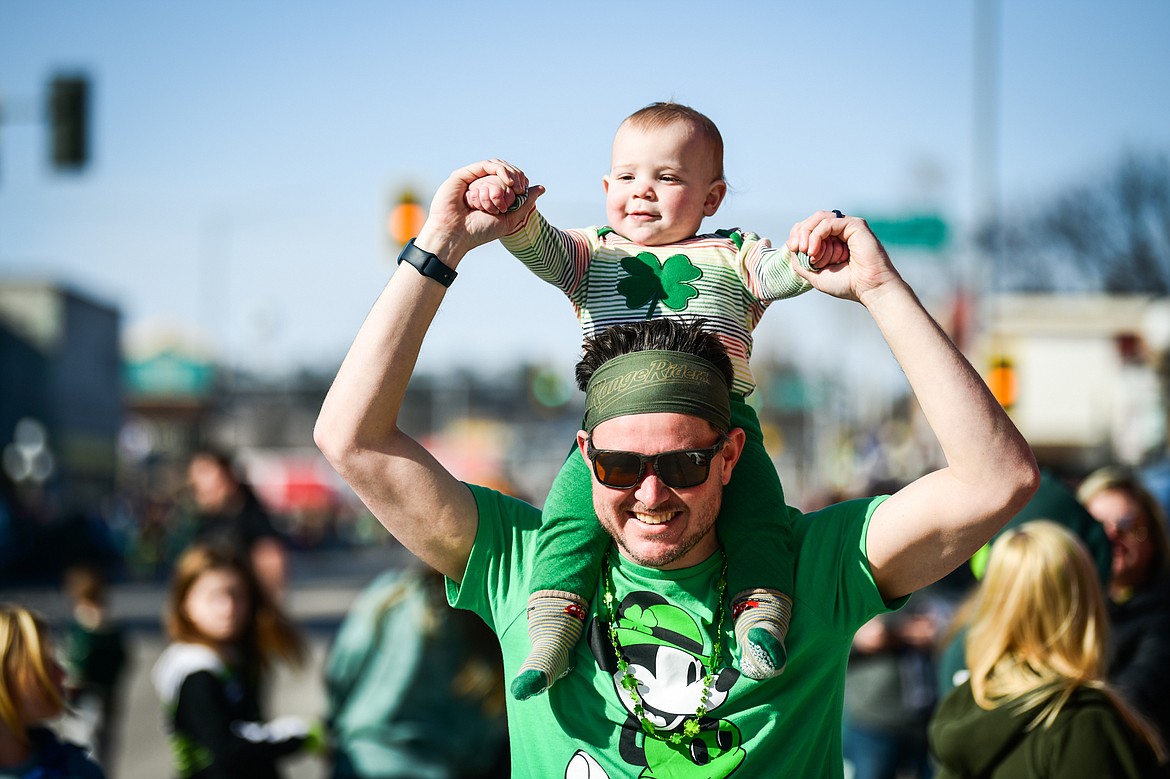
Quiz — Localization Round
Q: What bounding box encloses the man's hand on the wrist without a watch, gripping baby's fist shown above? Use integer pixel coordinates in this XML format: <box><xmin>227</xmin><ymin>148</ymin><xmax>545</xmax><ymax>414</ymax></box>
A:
<box><xmin>787</xmin><ymin>211</ymin><xmax>901</xmax><ymax>304</ymax></box>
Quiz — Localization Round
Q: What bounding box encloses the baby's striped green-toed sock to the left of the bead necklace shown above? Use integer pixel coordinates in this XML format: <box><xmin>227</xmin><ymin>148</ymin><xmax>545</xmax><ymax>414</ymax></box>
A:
<box><xmin>509</xmin><ymin>590</ymin><xmax>589</xmax><ymax>701</ymax></box>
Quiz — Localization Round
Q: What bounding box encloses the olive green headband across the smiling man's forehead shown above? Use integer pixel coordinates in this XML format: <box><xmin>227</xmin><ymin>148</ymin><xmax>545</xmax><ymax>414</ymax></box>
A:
<box><xmin>583</xmin><ymin>350</ymin><xmax>731</xmax><ymax>433</ymax></box>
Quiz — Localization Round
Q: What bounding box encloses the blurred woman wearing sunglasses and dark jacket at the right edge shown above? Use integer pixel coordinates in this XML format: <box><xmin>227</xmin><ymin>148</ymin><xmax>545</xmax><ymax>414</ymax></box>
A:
<box><xmin>1076</xmin><ymin>467</ymin><xmax>1170</xmax><ymax>743</ymax></box>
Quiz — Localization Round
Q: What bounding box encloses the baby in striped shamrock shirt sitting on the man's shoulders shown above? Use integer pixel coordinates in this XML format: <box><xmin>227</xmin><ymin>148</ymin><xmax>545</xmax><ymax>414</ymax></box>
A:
<box><xmin>467</xmin><ymin>103</ymin><xmax>845</xmax><ymax>699</ymax></box>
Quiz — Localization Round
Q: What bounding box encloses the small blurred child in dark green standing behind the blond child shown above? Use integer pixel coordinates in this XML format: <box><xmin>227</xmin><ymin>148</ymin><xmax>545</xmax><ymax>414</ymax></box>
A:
<box><xmin>63</xmin><ymin>566</ymin><xmax>126</xmax><ymax>765</ymax></box>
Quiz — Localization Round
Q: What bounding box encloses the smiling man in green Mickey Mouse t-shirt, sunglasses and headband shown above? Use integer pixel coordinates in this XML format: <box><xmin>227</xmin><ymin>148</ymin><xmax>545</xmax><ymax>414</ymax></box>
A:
<box><xmin>316</xmin><ymin>160</ymin><xmax>1039</xmax><ymax>778</ymax></box>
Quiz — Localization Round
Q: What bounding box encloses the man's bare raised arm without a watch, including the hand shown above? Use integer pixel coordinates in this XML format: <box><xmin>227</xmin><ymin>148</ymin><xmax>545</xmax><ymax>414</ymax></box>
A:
<box><xmin>789</xmin><ymin>212</ymin><xmax>1040</xmax><ymax>599</ymax></box>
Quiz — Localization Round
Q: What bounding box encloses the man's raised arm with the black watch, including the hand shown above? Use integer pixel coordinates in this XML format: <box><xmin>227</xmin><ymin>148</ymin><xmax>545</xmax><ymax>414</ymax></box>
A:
<box><xmin>314</xmin><ymin>160</ymin><xmax>543</xmax><ymax>581</ymax></box>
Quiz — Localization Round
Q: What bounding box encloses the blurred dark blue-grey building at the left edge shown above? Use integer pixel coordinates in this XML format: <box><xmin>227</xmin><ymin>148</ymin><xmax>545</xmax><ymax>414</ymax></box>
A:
<box><xmin>0</xmin><ymin>280</ymin><xmax>123</xmax><ymax>512</ymax></box>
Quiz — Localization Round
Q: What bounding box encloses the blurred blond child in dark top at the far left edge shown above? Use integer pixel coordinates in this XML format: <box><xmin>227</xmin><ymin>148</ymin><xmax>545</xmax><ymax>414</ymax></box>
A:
<box><xmin>0</xmin><ymin>605</ymin><xmax>105</xmax><ymax>779</ymax></box>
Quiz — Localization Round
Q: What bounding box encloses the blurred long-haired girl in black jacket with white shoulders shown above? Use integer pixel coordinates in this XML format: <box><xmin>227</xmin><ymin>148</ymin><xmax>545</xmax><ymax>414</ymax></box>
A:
<box><xmin>152</xmin><ymin>544</ymin><xmax>321</xmax><ymax>779</ymax></box>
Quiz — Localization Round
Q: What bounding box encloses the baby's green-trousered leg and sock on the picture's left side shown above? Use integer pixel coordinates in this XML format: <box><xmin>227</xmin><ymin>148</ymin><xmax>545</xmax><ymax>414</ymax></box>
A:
<box><xmin>509</xmin><ymin>447</ymin><xmax>610</xmax><ymax>701</ymax></box>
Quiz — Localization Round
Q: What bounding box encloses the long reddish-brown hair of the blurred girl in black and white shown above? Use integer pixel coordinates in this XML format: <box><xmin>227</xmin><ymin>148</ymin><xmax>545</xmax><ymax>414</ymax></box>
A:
<box><xmin>164</xmin><ymin>544</ymin><xmax>305</xmax><ymax>668</ymax></box>
